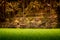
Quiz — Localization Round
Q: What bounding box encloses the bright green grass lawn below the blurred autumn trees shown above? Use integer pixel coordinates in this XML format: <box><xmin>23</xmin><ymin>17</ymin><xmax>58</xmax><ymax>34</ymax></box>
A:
<box><xmin>0</xmin><ymin>28</ymin><xmax>60</xmax><ymax>40</ymax></box>
